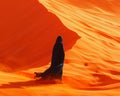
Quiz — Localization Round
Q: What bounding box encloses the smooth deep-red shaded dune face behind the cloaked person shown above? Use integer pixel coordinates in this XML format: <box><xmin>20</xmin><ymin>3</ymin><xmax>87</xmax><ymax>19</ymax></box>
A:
<box><xmin>0</xmin><ymin>0</ymin><xmax>79</xmax><ymax>71</ymax></box>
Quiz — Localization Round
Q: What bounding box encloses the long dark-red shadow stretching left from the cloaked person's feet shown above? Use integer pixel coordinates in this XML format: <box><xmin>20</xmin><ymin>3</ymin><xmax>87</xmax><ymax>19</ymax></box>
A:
<box><xmin>0</xmin><ymin>80</ymin><xmax>57</xmax><ymax>88</ymax></box>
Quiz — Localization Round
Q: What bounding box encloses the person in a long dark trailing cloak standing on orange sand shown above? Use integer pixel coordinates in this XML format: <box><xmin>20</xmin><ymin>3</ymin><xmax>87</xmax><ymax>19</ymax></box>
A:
<box><xmin>35</xmin><ymin>36</ymin><xmax>65</xmax><ymax>80</ymax></box>
